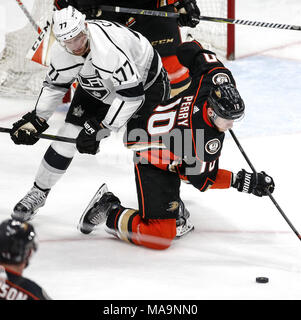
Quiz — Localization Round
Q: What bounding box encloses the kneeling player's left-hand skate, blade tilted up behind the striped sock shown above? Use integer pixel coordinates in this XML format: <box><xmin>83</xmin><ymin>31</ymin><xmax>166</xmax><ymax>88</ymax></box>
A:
<box><xmin>77</xmin><ymin>183</ymin><xmax>120</xmax><ymax>234</ymax></box>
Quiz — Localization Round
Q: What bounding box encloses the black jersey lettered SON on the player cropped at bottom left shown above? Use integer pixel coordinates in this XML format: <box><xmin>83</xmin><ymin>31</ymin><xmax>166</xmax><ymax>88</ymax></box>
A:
<box><xmin>0</xmin><ymin>268</ymin><xmax>50</xmax><ymax>300</ymax></box>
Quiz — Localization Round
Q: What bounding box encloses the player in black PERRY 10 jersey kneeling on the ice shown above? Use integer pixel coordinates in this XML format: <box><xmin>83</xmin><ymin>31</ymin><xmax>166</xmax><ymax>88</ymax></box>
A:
<box><xmin>79</xmin><ymin>41</ymin><xmax>274</xmax><ymax>249</ymax></box>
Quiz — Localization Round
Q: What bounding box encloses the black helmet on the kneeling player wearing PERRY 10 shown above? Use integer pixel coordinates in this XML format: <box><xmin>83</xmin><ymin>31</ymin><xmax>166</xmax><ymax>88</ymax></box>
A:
<box><xmin>208</xmin><ymin>83</ymin><xmax>245</xmax><ymax>120</ymax></box>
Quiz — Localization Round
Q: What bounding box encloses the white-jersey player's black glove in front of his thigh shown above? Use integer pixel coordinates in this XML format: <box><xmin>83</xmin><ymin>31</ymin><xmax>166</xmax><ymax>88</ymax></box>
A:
<box><xmin>76</xmin><ymin>119</ymin><xmax>101</xmax><ymax>154</ymax></box>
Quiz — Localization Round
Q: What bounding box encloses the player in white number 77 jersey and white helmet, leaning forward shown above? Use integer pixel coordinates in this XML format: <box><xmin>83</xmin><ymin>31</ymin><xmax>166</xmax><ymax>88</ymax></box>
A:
<box><xmin>11</xmin><ymin>6</ymin><xmax>170</xmax><ymax>221</ymax></box>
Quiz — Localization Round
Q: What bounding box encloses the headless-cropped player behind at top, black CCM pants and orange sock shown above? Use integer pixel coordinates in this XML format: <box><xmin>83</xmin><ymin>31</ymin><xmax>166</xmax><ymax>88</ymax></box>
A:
<box><xmin>55</xmin><ymin>0</ymin><xmax>200</xmax><ymax>96</ymax></box>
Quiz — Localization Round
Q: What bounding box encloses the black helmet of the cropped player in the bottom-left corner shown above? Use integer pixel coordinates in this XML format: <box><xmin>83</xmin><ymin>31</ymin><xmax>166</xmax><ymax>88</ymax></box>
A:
<box><xmin>0</xmin><ymin>219</ymin><xmax>37</xmax><ymax>265</ymax></box>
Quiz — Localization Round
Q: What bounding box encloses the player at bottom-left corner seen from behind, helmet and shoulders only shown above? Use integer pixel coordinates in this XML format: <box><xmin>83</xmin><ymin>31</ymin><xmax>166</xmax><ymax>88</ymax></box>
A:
<box><xmin>0</xmin><ymin>219</ymin><xmax>50</xmax><ymax>300</ymax></box>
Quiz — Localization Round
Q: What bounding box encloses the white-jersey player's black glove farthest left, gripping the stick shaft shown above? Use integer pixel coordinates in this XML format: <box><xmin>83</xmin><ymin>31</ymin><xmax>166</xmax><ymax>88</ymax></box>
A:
<box><xmin>10</xmin><ymin>111</ymin><xmax>49</xmax><ymax>145</ymax></box>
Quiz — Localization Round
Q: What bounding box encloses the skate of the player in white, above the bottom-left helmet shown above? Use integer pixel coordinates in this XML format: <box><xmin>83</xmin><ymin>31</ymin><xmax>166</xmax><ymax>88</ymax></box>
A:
<box><xmin>11</xmin><ymin>185</ymin><xmax>50</xmax><ymax>222</ymax></box>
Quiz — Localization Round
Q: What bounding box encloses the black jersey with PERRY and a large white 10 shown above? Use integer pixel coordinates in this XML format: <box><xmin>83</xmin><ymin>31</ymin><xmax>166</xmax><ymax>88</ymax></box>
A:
<box><xmin>125</xmin><ymin>41</ymin><xmax>235</xmax><ymax>191</ymax></box>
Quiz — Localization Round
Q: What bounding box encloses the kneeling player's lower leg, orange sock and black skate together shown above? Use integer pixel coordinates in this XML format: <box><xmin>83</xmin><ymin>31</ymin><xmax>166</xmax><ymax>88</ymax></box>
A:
<box><xmin>78</xmin><ymin>184</ymin><xmax>176</xmax><ymax>249</ymax></box>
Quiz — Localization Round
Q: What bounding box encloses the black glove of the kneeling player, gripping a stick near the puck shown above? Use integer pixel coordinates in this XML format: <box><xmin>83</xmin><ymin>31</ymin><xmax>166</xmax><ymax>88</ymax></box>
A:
<box><xmin>232</xmin><ymin>169</ymin><xmax>275</xmax><ymax>197</ymax></box>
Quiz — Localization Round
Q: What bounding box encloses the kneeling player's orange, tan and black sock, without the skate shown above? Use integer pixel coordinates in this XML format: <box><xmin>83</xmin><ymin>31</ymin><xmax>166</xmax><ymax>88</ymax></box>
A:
<box><xmin>106</xmin><ymin>207</ymin><xmax>176</xmax><ymax>250</ymax></box>
